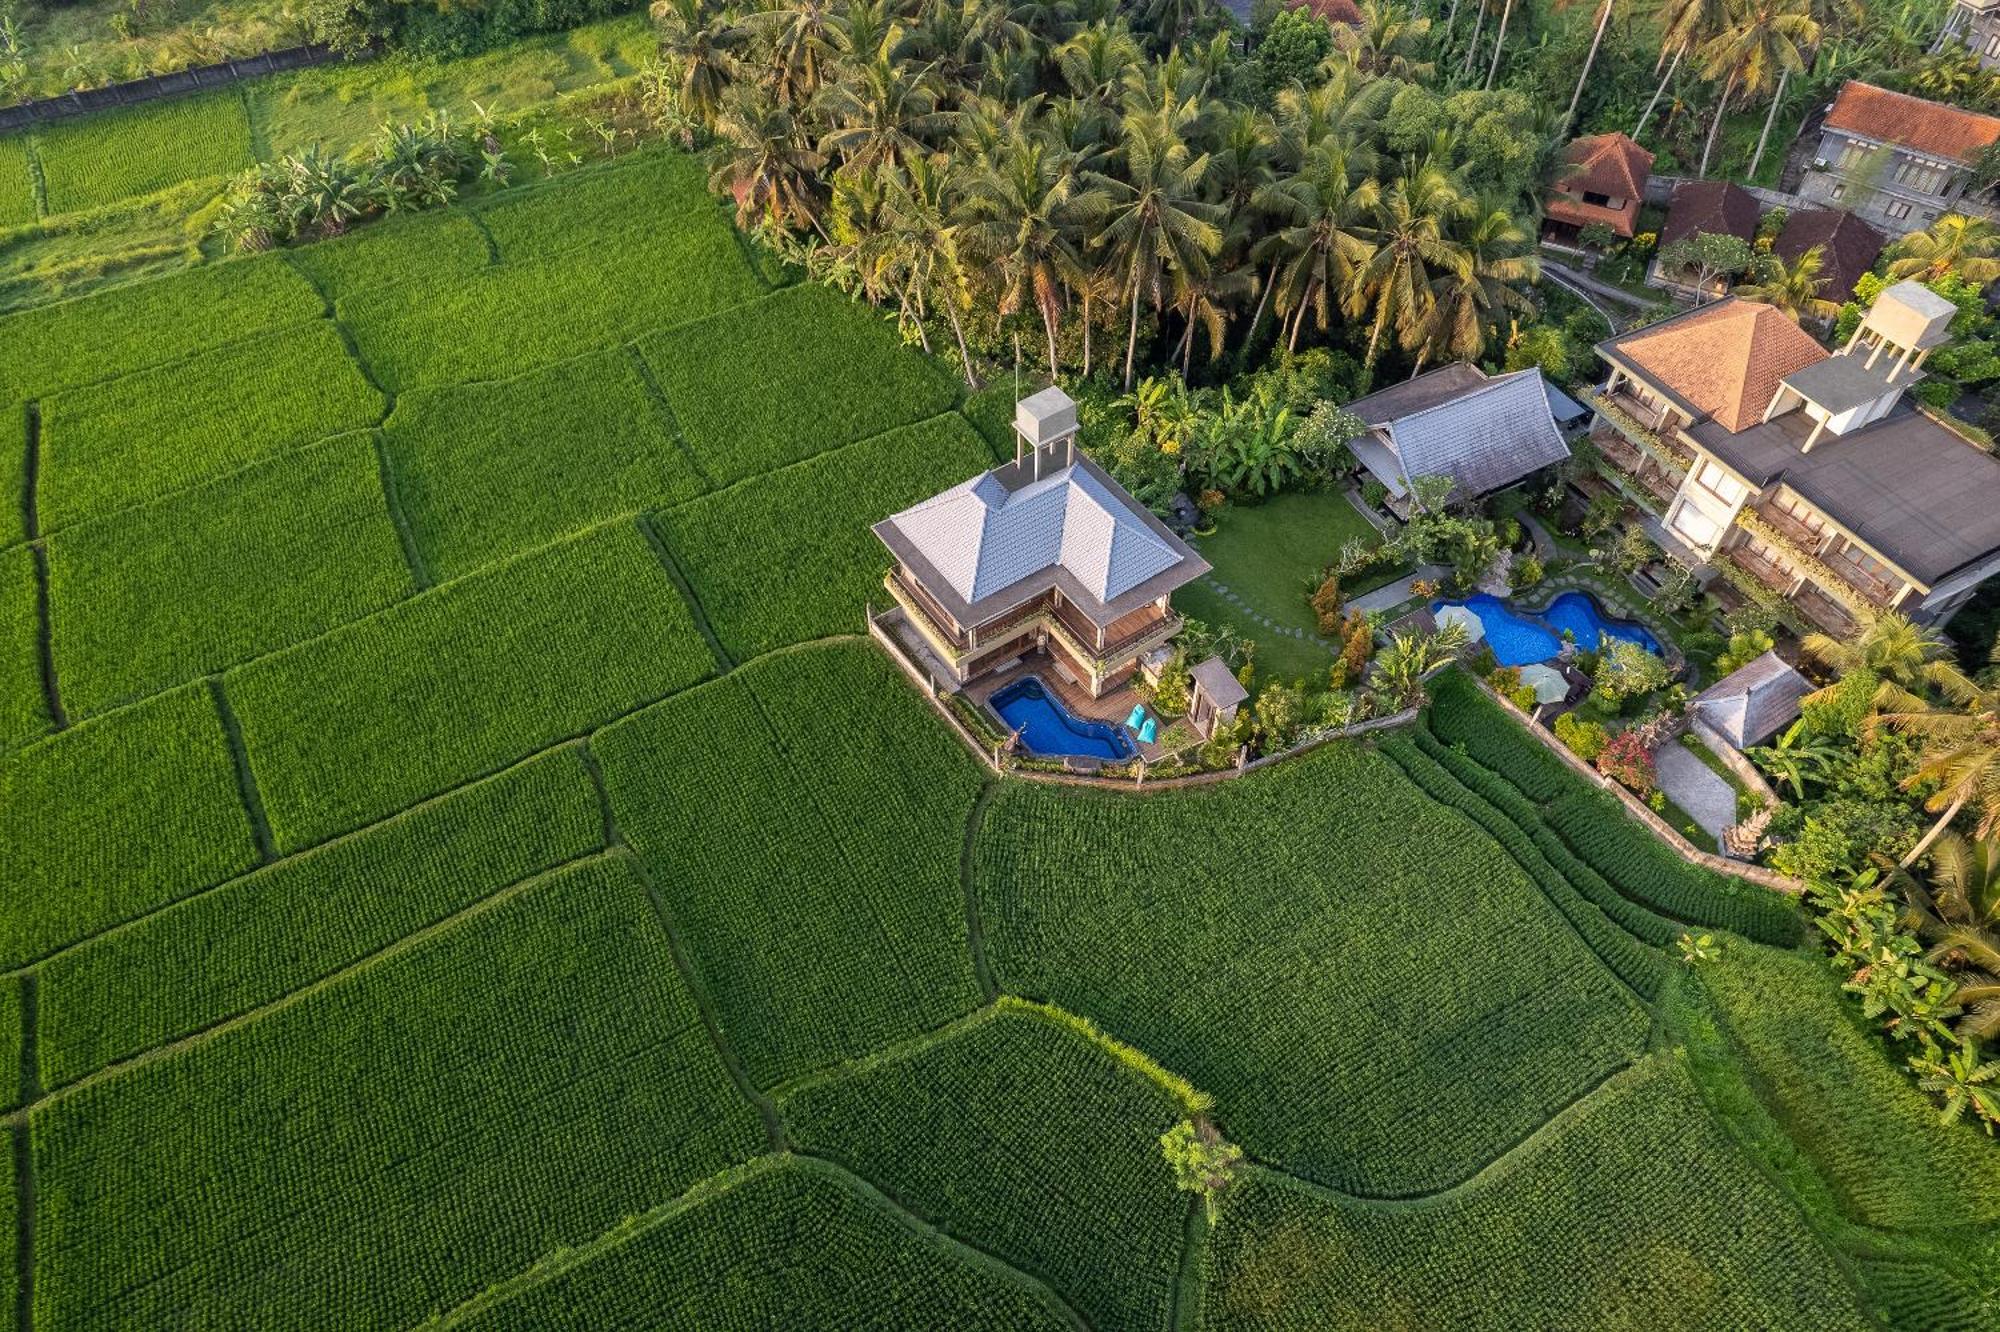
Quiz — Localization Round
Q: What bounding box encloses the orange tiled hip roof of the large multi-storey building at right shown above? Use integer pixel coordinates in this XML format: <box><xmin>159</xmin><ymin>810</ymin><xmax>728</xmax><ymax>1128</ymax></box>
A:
<box><xmin>1608</xmin><ymin>296</ymin><xmax>1826</xmax><ymax>434</ymax></box>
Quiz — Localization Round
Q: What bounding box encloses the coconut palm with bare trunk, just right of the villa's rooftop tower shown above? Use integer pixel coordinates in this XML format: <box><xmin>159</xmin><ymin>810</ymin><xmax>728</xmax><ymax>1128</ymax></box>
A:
<box><xmin>1098</xmin><ymin>120</ymin><xmax>1222</xmax><ymax>390</ymax></box>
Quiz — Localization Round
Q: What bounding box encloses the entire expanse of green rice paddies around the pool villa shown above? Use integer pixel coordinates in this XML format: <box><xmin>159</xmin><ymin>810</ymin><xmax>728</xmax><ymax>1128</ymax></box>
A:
<box><xmin>0</xmin><ymin>140</ymin><xmax>2000</xmax><ymax>1332</ymax></box>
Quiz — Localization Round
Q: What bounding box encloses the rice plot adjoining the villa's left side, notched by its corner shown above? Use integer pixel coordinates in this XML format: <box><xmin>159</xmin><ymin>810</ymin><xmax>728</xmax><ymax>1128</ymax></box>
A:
<box><xmin>656</xmin><ymin>414</ymin><xmax>992</xmax><ymax>660</ymax></box>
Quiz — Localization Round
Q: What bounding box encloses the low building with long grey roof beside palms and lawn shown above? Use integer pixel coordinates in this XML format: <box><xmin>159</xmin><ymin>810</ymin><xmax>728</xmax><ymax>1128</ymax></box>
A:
<box><xmin>1348</xmin><ymin>362</ymin><xmax>1570</xmax><ymax>512</ymax></box>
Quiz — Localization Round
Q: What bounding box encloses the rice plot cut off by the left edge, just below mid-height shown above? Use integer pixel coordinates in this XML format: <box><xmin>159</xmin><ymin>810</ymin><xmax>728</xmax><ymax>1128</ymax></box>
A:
<box><xmin>0</xmin><ymin>684</ymin><xmax>256</xmax><ymax>966</ymax></box>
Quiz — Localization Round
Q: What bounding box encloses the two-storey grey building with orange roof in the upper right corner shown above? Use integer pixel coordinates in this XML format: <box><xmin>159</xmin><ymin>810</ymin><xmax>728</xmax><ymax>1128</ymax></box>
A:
<box><xmin>1798</xmin><ymin>80</ymin><xmax>2000</xmax><ymax>236</ymax></box>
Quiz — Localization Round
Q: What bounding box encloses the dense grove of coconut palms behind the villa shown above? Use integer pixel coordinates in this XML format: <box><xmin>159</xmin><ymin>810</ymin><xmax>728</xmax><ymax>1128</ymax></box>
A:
<box><xmin>654</xmin><ymin>0</ymin><xmax>1552</xmax><ymax>388</ymax></box>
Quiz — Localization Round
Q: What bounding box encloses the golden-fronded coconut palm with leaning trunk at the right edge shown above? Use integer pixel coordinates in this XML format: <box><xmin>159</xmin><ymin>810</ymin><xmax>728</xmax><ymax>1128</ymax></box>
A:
<box><xmin>1878</xmin><ymin>662</ymin><xmax>2000</xmax><ymax>866</ymax></box>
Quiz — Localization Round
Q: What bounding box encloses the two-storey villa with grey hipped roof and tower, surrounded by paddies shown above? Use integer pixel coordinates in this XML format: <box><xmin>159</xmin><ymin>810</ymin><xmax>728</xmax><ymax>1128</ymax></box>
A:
<box><xmin>874</xmin><ymin>388</ymin><xmax>1208</xmax><ymax>698</ymax></box>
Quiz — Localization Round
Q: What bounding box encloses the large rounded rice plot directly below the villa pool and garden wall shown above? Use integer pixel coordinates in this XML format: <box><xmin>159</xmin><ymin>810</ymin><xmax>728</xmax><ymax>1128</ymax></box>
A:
<box><xmin>974</xmin><ymin>746</ymin><xmax>1650</xmax><ymax>1194</ymax></box>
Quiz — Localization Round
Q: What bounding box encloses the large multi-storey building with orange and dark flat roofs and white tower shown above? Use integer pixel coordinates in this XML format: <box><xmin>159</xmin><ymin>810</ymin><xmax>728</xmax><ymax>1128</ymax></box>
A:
<box><xmin>1592</xmin><ymin>282</ymin><xmax>2000</xmax><ymax>634</ymax></box>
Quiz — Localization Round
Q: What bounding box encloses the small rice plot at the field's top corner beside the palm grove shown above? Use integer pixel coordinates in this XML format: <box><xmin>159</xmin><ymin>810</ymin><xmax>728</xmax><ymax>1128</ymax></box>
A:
<box><xmin>478</xmin><ymin>150</ymin><xmax>718</xmax><ymax>262</ymax></box>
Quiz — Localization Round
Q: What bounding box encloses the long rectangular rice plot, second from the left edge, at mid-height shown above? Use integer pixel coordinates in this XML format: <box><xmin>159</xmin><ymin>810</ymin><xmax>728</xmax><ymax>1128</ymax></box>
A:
<box><xmin>226</xmin><ymin>522</ymin><xmax>714</xmax><ymax>850</ymax></box>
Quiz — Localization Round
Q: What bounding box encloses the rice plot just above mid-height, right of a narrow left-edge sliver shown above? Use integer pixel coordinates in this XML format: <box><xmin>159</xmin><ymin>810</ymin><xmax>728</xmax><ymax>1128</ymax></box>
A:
<box><xmin>48</xmin><ymin>434</ymin><xmax>416</xmax><ymax>718</ymax></box>
